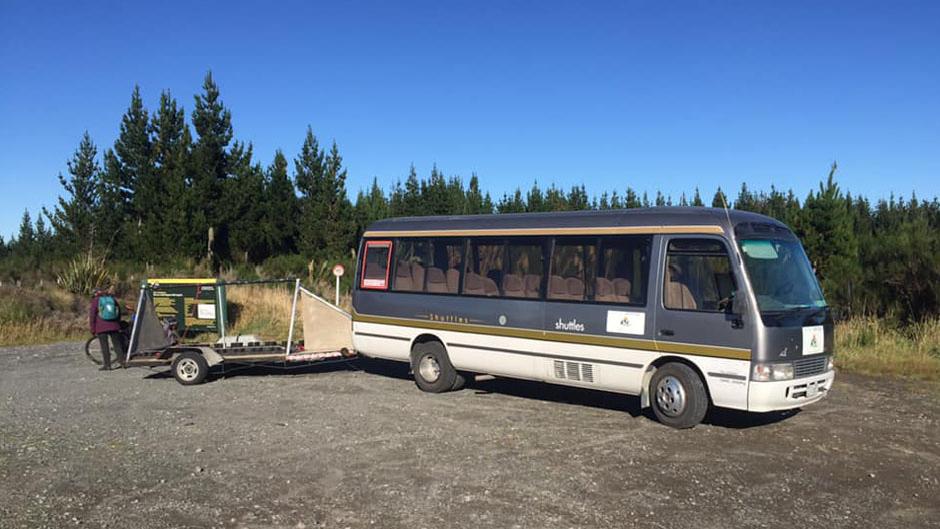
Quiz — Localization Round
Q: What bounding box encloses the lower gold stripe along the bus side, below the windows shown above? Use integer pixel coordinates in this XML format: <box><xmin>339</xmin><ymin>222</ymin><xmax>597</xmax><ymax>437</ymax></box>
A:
<box><xmin>353</xmin><ymin>311</ymin><xmax>751</xmax><ymax>360</ymax></box>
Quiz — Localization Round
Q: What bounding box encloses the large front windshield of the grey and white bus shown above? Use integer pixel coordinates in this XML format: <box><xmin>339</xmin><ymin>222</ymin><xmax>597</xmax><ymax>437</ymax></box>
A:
<box><xmin>739</xmin><ymin>239</ymin><xmax>826</xmax><ymax>312</ymax></box>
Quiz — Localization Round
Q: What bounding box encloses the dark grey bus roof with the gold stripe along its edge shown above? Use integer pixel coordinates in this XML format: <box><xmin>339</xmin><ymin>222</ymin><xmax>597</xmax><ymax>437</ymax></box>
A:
<box><xmin>364</xmin><ymin>207</ymin><xmax>787</xmax><ymax>237</ymax></box>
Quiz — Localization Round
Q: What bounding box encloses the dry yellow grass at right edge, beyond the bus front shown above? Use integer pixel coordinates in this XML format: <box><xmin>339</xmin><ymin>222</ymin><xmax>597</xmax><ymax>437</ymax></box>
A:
<box><xmin>836</xmin><ymin>318</ymin><xmax>940</xmax><ymax>381</ymax></box>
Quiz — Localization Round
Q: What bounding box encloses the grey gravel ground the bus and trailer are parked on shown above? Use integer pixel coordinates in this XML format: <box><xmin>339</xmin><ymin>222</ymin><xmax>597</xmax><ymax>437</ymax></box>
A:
<box><xmin>0</xmin><ymin>344</ymin><xmax>940</xmax><ymax>529</ymax></box>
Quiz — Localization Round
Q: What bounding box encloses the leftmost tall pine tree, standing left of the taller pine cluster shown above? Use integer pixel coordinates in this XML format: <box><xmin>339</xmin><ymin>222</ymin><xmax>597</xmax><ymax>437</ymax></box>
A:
<box><xmin>44</xmin><ymin>131</ymin><xmax>101</xmax><ymax>254</ymax></box>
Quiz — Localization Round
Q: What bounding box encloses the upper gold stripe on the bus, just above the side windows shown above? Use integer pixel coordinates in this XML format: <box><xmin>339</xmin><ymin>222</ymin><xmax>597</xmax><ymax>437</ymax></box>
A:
<box><xmin>362</xmin><ymin>226</ymin><xmax>724</xmax><ymax>238</ymax></box>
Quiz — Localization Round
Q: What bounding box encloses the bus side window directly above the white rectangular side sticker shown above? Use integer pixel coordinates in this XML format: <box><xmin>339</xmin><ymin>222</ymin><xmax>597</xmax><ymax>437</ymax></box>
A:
<box><xmin>594</xmin><ymin>235</ymin><xmax>652</xmax><ymax>306</ymax></box>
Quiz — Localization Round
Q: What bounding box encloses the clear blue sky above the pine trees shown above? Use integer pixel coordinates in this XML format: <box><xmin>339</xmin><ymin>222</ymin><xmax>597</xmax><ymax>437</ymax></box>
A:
<box><xmin>0</xmin><ymin>0</ymin><xmax>940</xmax><ymax>238</ymax></box>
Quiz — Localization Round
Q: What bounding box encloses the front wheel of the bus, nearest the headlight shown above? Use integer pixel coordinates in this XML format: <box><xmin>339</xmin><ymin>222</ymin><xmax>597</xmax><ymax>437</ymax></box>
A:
<box><xmin>649</xmin><ymin>362</ymin><xmax>708</xmax><ymax>429</ymax></box>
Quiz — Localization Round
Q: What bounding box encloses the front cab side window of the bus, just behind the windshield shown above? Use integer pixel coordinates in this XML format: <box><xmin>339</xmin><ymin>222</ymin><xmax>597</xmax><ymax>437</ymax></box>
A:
<box><xmin>663</xmin><ymin>239</ymin><xmax>735</xmax><ymax>312</ymax></box>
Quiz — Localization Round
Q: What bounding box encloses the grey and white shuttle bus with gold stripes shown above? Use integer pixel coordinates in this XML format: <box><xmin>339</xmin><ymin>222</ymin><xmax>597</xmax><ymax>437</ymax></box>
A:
<box><xmin>353</xmin><ymin>208</ymin><xmax>834</xmax><ymax>428</ymax></box>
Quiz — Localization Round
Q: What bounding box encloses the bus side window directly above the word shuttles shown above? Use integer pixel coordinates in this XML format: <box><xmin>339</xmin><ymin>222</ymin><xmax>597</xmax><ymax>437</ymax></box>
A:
<box><xmin>547</xmin><ymin>238</ymin><xmax>597</xmax><ymax>301</ymax></box>
